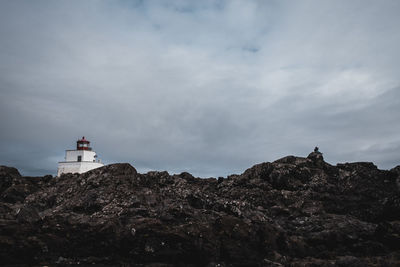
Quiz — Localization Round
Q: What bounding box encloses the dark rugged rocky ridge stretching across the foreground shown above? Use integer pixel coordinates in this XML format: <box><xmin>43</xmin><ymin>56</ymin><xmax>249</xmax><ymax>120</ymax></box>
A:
<box><xmin>0</xmin><ymin>154</ymin><xmax>400</xmax><ymax>266</ymax></box>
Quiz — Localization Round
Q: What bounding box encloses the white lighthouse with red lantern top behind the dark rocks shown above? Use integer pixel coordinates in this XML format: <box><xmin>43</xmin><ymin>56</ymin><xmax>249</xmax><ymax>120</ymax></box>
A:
<box><xmin>57</xmin><ymin>136</ymin><xmax>104</xmax><ymax>176</ymax></box>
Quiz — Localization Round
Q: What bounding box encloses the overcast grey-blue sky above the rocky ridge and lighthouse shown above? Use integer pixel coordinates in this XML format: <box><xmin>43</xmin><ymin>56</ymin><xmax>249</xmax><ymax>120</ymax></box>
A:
<box><xmin>0</xmin><ymin>0</ymin><xmax>400</xmax><ymax>177</ymax></box>
